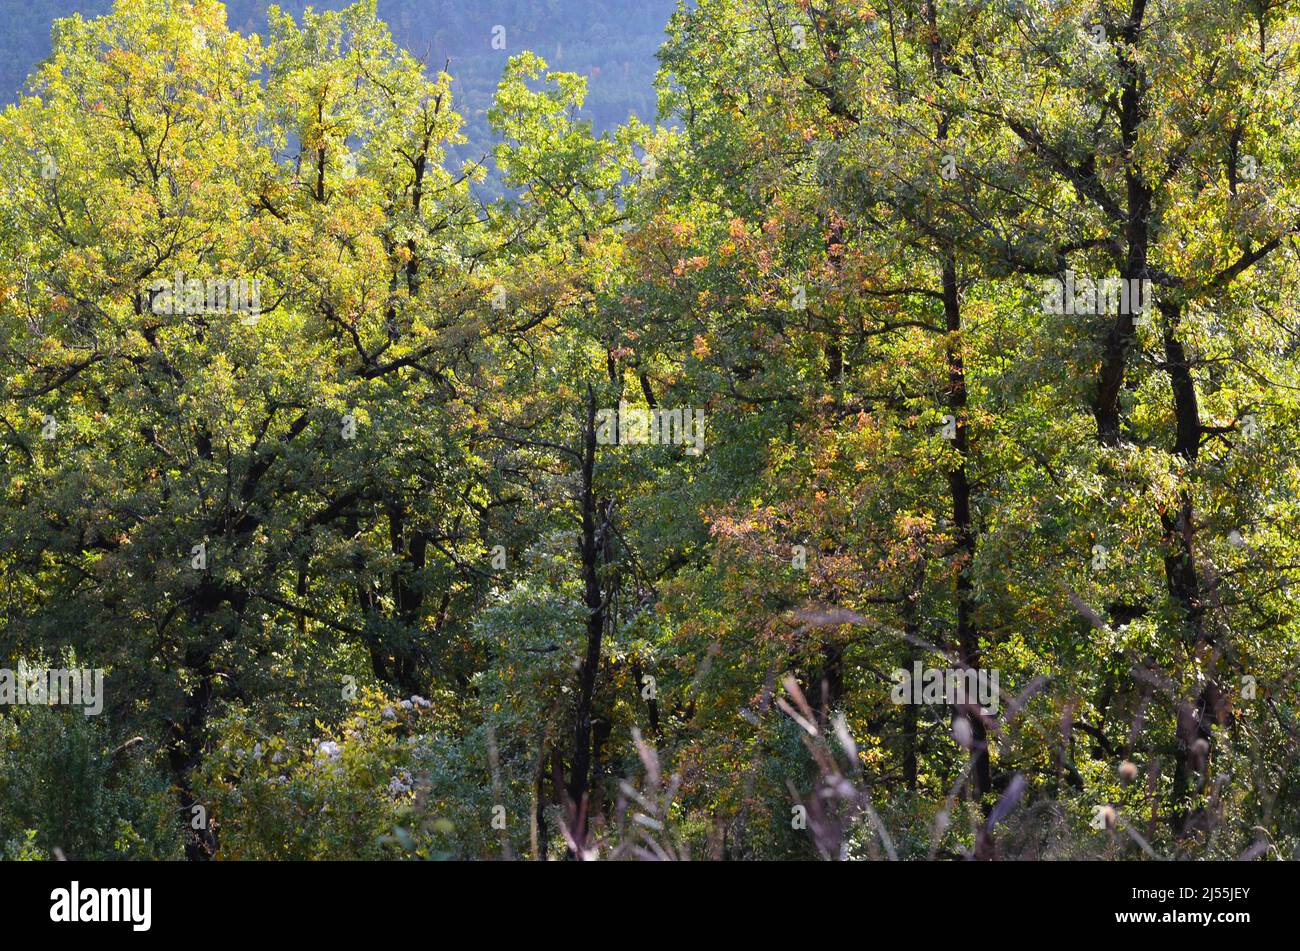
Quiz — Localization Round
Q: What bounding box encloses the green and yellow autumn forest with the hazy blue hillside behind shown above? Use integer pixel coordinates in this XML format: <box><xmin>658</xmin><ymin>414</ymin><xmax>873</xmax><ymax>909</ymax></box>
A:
<box><xmin>0</xmin><ymin>0</ymin><xmax>1300</xmax><ymax>860</ymax></box>
